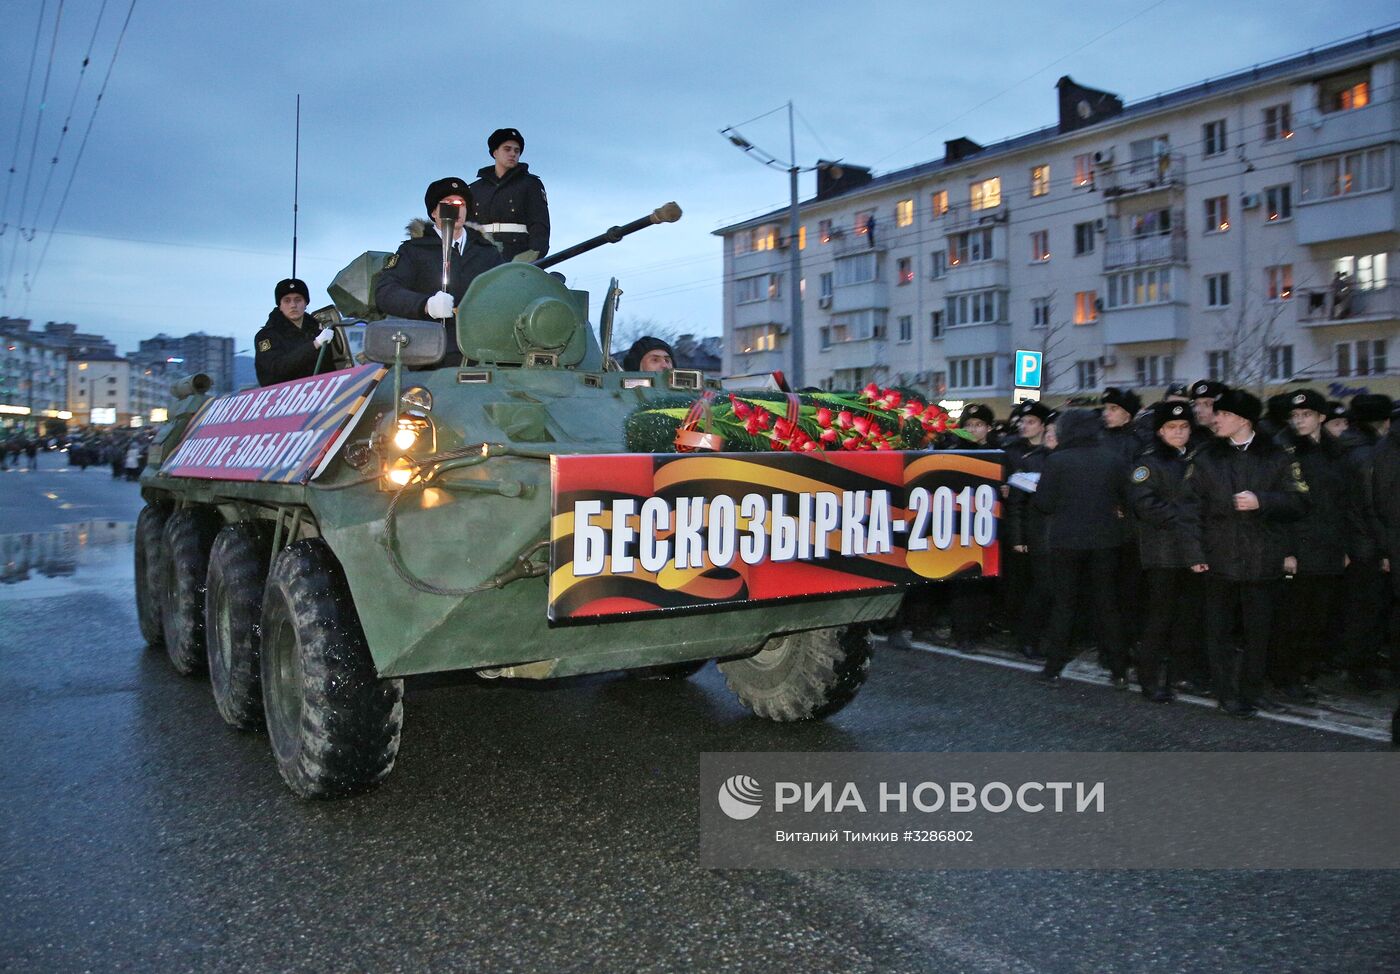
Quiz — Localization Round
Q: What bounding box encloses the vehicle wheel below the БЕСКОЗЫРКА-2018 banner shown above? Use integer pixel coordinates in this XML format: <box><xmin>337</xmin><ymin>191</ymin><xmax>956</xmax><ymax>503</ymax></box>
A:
<box><xmin>720</xmin><ymin>627</ymin><xmax>871</xmax><ymax>721</ymax></box>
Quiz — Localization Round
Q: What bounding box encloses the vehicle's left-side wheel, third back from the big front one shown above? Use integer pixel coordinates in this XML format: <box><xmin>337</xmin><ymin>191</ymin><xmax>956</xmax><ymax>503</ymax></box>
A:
<box><xmin>161</xmin><ymin>507</ymin><xmax>223</xmax><ymax>676</ymax></box>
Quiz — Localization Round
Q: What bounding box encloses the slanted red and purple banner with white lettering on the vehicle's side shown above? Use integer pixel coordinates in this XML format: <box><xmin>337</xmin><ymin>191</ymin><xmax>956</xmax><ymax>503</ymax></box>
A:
<box><xmin>161</xmin><ymin>365</ymin><xmax>388</xmax><ymax>484</ymax></box>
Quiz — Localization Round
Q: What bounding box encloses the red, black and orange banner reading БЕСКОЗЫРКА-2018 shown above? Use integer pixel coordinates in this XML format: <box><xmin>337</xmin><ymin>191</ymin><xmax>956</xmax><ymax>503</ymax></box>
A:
<box><xmin>549</xmin><ymin>451</ymin><xmax>1002</xmax><ymax>621</ymax></box>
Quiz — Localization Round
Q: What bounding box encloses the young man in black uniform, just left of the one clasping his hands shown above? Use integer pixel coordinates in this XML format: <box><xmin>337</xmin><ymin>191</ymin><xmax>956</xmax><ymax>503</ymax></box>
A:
<box><xmin>1128</xmin><ymin>402</ymin><xmax>1204</xmax><ymax>704</ymax></box>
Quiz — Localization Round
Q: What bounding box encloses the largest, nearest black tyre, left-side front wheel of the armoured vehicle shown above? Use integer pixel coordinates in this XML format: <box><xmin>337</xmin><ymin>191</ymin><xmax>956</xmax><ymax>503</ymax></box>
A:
<box><xmin>259</xmin><ymin>539</ymin><xmax>403</xmax><ymax>798</ymax></box>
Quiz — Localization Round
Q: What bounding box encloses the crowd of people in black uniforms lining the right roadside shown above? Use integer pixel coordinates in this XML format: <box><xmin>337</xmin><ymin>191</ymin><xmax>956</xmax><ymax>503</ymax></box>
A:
<box><xmin>896</xmin><ymin>381</ymin><xmax>1400</xmax><ymax>718</ymax></box>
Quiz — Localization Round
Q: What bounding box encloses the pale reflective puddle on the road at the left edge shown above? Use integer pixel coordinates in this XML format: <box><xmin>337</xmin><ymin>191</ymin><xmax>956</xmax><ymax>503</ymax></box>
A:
<box><xmin>0</xmin><ymin>521</ymin><xmax>136</xmax><ymax>600</ymax></box>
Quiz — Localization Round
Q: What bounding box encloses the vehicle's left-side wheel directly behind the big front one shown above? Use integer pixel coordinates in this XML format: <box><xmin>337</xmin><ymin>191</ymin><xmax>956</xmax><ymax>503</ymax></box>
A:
<box><xmin>204</xmin><ymin>521</ymin><xmax>272</xmax><ymax>731</ymax></box>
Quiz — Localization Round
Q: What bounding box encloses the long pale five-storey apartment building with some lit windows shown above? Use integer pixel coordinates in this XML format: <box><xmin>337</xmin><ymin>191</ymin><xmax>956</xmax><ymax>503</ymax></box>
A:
<box><xmin>715</xmin><ymin>29</ymin><xmax>1400</xmax><ymax>406</ymax></box>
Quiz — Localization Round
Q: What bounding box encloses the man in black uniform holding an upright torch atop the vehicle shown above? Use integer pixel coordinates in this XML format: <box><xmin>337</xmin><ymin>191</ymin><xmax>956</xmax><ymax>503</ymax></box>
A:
<box><xmin>374</xmin><ymin>176</ymin><xmax>504</xmax><ymax>365</ymax></box>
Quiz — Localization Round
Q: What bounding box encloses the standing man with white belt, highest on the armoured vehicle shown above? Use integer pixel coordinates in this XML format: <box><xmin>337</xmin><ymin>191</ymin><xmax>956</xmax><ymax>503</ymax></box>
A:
<box><xmin>472</xmin><ymin>129</ymin><xmax>549</xmax><ymax>260</ymax></box>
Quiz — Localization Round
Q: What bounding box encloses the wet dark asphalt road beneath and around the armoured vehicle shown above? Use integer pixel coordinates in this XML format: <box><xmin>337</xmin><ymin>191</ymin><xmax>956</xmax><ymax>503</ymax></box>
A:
<box><xmin>0</xmin><ymin>459</ymin><xmax>1400</xmax><ymax>974</ymax></box>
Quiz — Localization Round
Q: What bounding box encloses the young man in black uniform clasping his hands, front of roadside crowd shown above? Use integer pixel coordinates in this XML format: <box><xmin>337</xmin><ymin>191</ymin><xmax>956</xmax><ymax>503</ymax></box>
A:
<box><xmin>1183</xmin><ymin>389</ymin><xmax>1308</xmax><ymax>717</ymax></box>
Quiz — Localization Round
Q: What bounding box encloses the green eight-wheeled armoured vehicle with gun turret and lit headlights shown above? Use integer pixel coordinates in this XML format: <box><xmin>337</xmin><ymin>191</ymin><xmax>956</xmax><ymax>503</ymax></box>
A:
<box><xmin>136</xmin><ymin>204</ymin><xmax>900</xmax><ymax>798</ymax></box>
